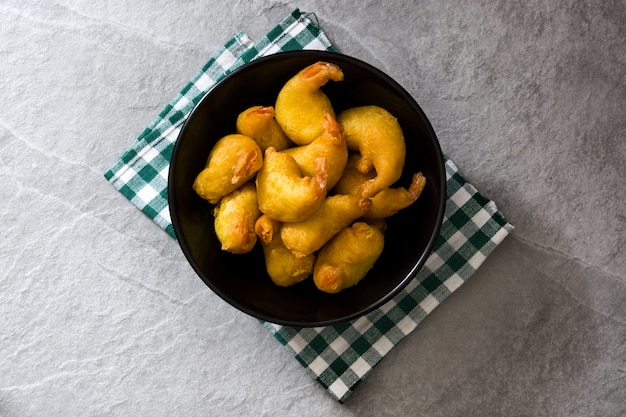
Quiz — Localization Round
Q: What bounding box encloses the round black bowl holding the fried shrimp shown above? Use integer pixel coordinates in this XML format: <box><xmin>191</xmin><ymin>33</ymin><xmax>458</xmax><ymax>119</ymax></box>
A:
<box><xmin>168</xmin><ymin>51</ymin><xmax>446</xmax><ymax>327</ymax></box>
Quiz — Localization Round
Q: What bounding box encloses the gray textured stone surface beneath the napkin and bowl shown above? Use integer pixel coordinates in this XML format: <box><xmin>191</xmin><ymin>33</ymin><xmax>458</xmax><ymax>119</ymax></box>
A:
<box><xmin>0</xmin><ymin>0</ymin><xmax>626</xmax><ymax>417</ymax></box>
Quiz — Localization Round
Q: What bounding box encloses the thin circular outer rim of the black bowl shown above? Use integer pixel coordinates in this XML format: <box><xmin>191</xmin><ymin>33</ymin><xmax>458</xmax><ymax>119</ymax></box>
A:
<box><xmin>167</xmin><ymin>50</ymin><xmax>447</xmax><ymax>328</ymax></box>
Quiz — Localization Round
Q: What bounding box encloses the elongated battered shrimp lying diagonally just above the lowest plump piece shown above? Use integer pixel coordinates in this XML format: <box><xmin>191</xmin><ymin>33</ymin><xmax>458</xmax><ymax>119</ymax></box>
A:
<box><xmin>280</xmin><ymin>194</ymin><xmax>371</xmax><ymax>257</ymax></box>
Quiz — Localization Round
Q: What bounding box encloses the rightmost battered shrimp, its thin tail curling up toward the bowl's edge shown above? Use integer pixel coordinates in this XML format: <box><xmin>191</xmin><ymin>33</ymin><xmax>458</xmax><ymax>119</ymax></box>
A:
<box><xmin>363</xmin><ymin>172</ymin><xmax>426</xmax><ymax>219</ymax></box>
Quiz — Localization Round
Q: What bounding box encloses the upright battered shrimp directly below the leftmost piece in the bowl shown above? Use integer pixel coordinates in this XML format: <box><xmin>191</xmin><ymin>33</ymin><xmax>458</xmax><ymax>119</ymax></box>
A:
<box><xmin>213</xmin><ymin>182</ymin><xmax>261</xmax><ymax>253</ymax></box>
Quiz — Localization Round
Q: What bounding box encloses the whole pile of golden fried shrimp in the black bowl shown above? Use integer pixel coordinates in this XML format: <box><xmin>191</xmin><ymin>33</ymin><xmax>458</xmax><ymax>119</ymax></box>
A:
<box><xmin>193</xmin><ymin>61</ymin><xmax>426</xmax><ymax>293</ymax></box>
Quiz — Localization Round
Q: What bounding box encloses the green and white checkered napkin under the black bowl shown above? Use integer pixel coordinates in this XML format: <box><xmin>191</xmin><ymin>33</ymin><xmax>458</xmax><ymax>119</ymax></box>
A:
<box><xmin>105</xmin><ymin>9</ymin><xmax>513</xmax><ymax>402</ymax></box>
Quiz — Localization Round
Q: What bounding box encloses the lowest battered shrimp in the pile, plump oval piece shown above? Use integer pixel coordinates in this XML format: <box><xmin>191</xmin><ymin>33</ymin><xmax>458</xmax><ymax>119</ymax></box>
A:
<box><xmin>313</xmin><ymin>222</ymin><xmax>384</xmax><ymax>294</ymax></box>
